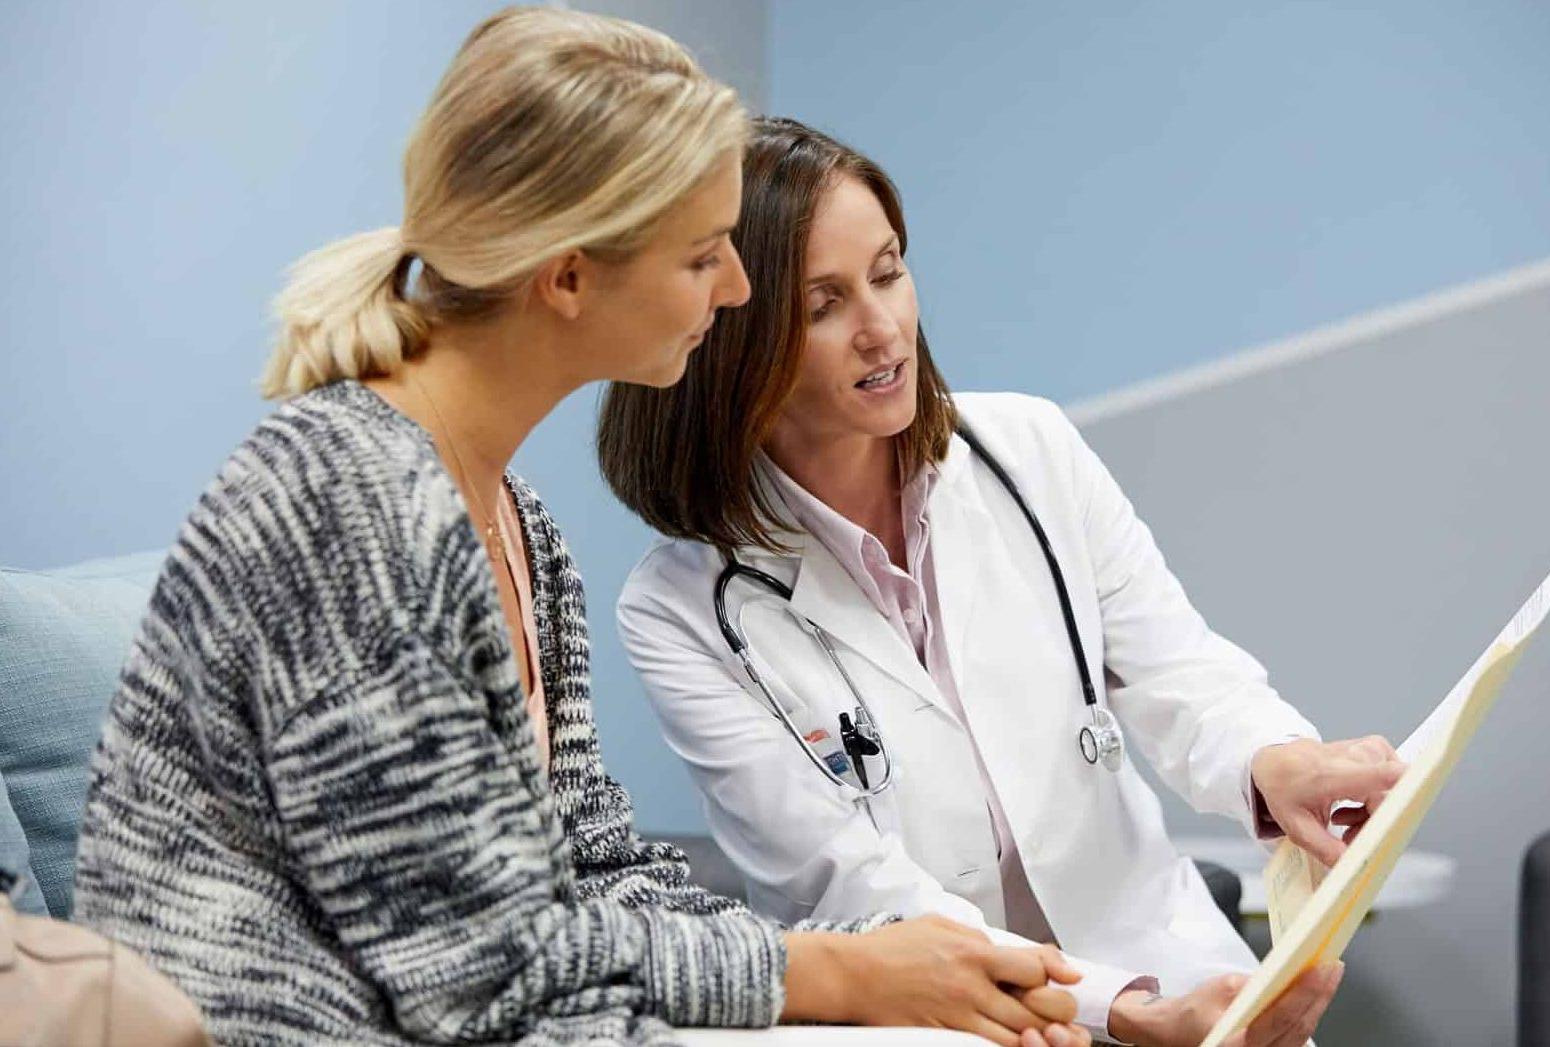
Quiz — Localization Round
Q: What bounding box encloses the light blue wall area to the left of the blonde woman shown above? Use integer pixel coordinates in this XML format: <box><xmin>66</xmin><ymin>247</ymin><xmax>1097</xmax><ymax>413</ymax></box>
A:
<box><xmin>0</xmin><ymin>0</ymin><xmax>491</xmax><ymax>566</ymax></box>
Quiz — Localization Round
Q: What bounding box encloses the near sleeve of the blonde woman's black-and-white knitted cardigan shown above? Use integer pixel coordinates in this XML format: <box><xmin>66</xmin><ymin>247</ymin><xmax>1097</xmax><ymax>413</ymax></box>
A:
<box><xmin>270</xmin><ymin>611</ymin><xmax>784</xmax><ymax>1042</ymax></box>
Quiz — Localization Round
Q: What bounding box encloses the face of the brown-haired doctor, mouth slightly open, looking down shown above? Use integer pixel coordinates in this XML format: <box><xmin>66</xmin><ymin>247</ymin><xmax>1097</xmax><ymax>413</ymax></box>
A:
<box><xmin>777</xmin><ymin>175</ymin><xmax>919</xmax><ymax>448</ymax></box>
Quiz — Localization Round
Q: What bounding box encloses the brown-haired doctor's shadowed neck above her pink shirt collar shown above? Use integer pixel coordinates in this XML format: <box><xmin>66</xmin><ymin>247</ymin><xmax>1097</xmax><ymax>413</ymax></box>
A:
<box><xmin>764</xmin><ymin>427</ymin><xmax>904</xmax><ymax>539</ymax></box>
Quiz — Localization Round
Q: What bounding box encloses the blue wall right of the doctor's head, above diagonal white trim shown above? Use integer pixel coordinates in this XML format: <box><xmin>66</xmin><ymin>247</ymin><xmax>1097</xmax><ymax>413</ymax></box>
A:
<box><xmin>769</xmin><ymin>0</ymin><xmax>1550</xmax><ymax>400</ymax></box>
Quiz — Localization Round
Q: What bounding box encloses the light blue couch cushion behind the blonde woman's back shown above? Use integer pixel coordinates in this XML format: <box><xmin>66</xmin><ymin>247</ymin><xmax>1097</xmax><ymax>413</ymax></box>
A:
<box><xmin>0</xmin><ymin>552</ymin><xmax>164</xmax><ymax>918</ymax></box>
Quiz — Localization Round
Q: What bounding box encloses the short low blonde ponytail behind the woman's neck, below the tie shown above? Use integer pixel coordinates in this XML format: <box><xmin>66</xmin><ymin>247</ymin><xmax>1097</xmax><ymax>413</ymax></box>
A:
<box><xmin>259</xmin><ymin>226</ymin><xmax>428</xmax><ymax>399</ymax></box>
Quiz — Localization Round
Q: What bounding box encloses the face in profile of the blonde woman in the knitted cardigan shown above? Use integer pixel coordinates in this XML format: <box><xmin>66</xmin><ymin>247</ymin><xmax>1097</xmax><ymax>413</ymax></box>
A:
<box><xmin>580</xmin><ymin>155</ymin><xmax>749</xmax><ymax>386</ymax></box>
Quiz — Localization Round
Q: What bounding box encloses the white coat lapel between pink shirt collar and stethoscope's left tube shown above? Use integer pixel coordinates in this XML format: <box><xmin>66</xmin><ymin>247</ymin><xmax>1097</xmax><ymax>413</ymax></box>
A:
<box><xmin>742</xmin><ymin>532</ymin><xmax>942</xmax><ymax>707</ymax></box>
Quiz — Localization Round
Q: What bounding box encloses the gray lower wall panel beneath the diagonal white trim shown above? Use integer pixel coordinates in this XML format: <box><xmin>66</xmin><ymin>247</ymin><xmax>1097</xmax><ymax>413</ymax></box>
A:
<box><xmin>1073</xmin><ymin>266</ymin><xmax>1550</xmax><ymax>1047</ymax></box>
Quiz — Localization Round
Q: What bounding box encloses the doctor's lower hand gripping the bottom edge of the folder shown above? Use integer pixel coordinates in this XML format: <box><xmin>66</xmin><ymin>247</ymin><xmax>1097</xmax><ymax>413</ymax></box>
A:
<box><xmin>1108</xmin><ymin>963</ymin><xmax>1345</xmax><ymax>1047</ymax></box>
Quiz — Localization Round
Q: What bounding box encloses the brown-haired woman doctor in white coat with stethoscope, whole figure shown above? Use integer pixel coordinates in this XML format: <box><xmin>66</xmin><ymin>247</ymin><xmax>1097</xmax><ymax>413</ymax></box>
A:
<box><xmin>600</xmin><ymin>121</ymin><xmax>1403</xmax><ymax>1044</ymax></box>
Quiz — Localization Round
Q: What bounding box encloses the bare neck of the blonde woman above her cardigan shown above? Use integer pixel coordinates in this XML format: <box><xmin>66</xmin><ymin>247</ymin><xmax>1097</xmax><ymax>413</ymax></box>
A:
<box><xmin>366</xmin><ymin>305</ymin><xmax>586</xmax><ymax>513</ymax></box>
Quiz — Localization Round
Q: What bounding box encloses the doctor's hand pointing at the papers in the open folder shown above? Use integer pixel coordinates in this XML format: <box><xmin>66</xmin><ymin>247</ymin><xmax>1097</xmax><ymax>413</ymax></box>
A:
<box><xmin>1249</xmin><ymin>735</ymin><xmax>1406</xmax><ymax>866</ymax></box>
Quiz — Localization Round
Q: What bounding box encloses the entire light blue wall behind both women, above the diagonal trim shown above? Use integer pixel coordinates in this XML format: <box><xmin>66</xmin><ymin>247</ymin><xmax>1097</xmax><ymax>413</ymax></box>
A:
<box><xmin>0</xmin><ymin>0</ymin><xmax>1550</xmax><ymax>830</ymax></box>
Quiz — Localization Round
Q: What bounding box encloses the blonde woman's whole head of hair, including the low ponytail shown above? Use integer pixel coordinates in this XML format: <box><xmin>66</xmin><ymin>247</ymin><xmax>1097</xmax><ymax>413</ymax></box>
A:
<box><xmin>260</xmin><ymin>8</ymin><xmax>747</xmax><ymax>397</ymax></box>
